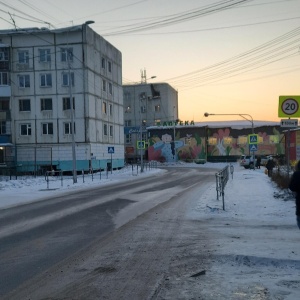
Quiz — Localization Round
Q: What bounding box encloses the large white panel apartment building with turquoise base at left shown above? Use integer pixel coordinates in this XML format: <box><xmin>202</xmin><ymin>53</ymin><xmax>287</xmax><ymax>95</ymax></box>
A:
<box><xmin>0</xmin><ymin>24</ymin><xmax>124</xmax><ymax>171</ymax></box>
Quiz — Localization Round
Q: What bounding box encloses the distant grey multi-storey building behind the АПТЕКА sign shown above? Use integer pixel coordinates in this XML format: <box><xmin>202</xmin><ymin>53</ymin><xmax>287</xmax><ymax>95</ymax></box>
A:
<box><xmin>123</xmin><ymin>82</ymin><xmax>178</xmax><ymax>162</ymax></box>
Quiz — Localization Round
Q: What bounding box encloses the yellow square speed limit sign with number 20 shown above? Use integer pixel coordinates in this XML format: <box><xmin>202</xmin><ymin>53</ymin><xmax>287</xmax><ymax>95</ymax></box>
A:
<box><xmin>278</xmin><ymin>96</ymin><xmax>300</xmax><ymax>118</ymax></box>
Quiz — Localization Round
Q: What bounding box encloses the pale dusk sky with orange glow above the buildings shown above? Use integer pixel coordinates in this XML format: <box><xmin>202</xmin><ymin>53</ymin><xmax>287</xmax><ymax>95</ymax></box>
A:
<box><xmin>0</xmin><ymin>0</ymin><xmax>300</xmax><ymax>122</ymax></box>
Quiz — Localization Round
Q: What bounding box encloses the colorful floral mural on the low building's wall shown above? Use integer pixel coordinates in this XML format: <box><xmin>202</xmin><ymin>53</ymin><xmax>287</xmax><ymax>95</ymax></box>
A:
<box><xmin>148</xmin><ymin>126</ymin><xmax>284</xmax><ymax>162</ymax></box>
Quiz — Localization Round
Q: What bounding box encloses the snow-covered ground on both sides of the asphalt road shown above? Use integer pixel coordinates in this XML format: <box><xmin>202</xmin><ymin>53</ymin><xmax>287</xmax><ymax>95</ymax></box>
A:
<box><xmin>0</xmin><ymin>163</ymin><xmax>300</xmax><ymax>300</ymax></box>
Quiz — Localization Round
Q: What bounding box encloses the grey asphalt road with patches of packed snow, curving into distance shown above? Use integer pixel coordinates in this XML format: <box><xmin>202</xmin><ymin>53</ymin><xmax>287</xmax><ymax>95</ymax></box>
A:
<box><xmin>0</xmin><ymin>168</ymin><xmax>216</xmax><ymax>300</ymax></box>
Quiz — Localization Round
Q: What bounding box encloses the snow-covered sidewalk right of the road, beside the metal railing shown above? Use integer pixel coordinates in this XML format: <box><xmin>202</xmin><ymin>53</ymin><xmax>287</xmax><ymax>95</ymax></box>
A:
<box><xmin>183</xmin><ymin>164</ymin><xmax>300</xmax><ymax>300</ymax></box>
